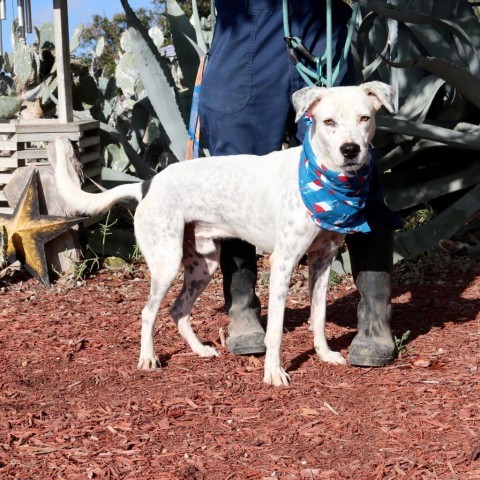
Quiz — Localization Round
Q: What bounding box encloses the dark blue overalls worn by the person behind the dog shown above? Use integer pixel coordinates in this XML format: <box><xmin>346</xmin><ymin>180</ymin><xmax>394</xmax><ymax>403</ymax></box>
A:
<box><xmin>199</xmin><ymin>0</ymin><xmax>401</xmax><ymax>228</ymax></box>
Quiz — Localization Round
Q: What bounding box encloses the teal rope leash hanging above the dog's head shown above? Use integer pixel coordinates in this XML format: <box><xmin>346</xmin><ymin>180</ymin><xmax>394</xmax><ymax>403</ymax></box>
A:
<box><xmin>283</xmin><ymin>0</ymin><xmax>359</xmax><ymax>87</ymax></box>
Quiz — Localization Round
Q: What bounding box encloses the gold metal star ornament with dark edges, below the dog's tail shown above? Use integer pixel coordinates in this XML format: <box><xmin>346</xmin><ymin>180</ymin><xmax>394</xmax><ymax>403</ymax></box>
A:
<box><xmin>0</xmin><ymin>170</ymin><xmax>85</xmax><ymax>286</ymax></box>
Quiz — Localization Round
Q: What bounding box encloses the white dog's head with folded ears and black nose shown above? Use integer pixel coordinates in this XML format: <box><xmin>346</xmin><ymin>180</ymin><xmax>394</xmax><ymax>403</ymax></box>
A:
<box><xmin>292</xmin><ymin>82</ymin><xmax>394</xmax><ymax>172</ymax></box>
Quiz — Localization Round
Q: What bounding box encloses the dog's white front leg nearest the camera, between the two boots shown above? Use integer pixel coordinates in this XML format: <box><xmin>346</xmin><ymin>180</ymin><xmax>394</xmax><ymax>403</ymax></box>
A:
<box><xmin>263</xmin><ymin>253</ymin><xmax>295</xmax><ymax>386</ymax></box>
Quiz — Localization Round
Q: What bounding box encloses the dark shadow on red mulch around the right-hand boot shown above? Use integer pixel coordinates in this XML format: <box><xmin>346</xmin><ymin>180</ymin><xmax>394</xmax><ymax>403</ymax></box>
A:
<box><xmin>262</xmin><ymin>251</ymin><xmax>480</xmax><ymax>370</ymax></box>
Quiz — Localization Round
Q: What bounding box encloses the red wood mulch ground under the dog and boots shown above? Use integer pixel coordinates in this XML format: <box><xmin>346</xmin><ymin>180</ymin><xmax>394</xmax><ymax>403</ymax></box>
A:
<box><xmin>0</xmin><ymin>251</ymin><xmax>480</xmax><ymax>480</ymax></box>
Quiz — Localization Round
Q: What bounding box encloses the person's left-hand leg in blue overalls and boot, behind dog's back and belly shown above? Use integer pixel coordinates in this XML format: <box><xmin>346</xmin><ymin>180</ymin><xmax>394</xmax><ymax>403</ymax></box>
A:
<box><xmin>200</xmin><ymin>2</ymin><xmax>290</xmax><ymax>355</ymax></box>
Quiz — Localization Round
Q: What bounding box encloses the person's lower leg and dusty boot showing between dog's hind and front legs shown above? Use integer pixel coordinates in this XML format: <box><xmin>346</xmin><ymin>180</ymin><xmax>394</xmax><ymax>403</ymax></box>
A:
<box><xmin>220</xmin><ymin>239</ymin><xmax>266</xmax><ymax>355</ymax></box>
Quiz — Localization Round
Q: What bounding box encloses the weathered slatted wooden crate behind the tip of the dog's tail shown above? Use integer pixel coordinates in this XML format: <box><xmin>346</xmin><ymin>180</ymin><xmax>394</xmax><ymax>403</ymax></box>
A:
<box><xmin>0</xmin><ymin>119</ymin><xmax>101</xmax><ymax>213</ymax></box>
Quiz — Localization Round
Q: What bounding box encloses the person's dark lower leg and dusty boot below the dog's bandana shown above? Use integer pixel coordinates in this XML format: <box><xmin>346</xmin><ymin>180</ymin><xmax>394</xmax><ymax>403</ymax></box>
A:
<box><xmin>346</xmin><ymin>222</ymin><xmax>395</xmax><ymax>367</ymax></box>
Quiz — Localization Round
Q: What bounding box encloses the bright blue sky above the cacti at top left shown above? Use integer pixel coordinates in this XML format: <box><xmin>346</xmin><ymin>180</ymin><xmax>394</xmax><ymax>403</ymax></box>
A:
<box><xmin>1</xmin><ymin>0</ymin><xmax>152</xmax><ymax>52</ymax></box>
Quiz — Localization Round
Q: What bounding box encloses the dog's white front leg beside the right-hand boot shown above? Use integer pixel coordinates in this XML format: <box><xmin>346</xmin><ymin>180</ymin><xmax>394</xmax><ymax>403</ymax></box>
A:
<box><xmin>308</xmin><ymin>245</ymin><xmax>346</xmax><ymax>365</ymax></box>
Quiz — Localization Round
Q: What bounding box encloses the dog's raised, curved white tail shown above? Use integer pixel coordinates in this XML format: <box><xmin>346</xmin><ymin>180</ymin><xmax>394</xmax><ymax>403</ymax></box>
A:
<box><xmin>49</xmin><ymin>137</ymin><xmax>142</xmax><ymax>216</ymax></box>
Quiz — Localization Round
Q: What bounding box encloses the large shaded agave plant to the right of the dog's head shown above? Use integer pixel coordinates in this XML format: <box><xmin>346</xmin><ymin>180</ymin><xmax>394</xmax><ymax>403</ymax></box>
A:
<box><xmin>354</xmin><ymin>0</ymin><xmax>480</xmax><ymax>258</ymax></box>
